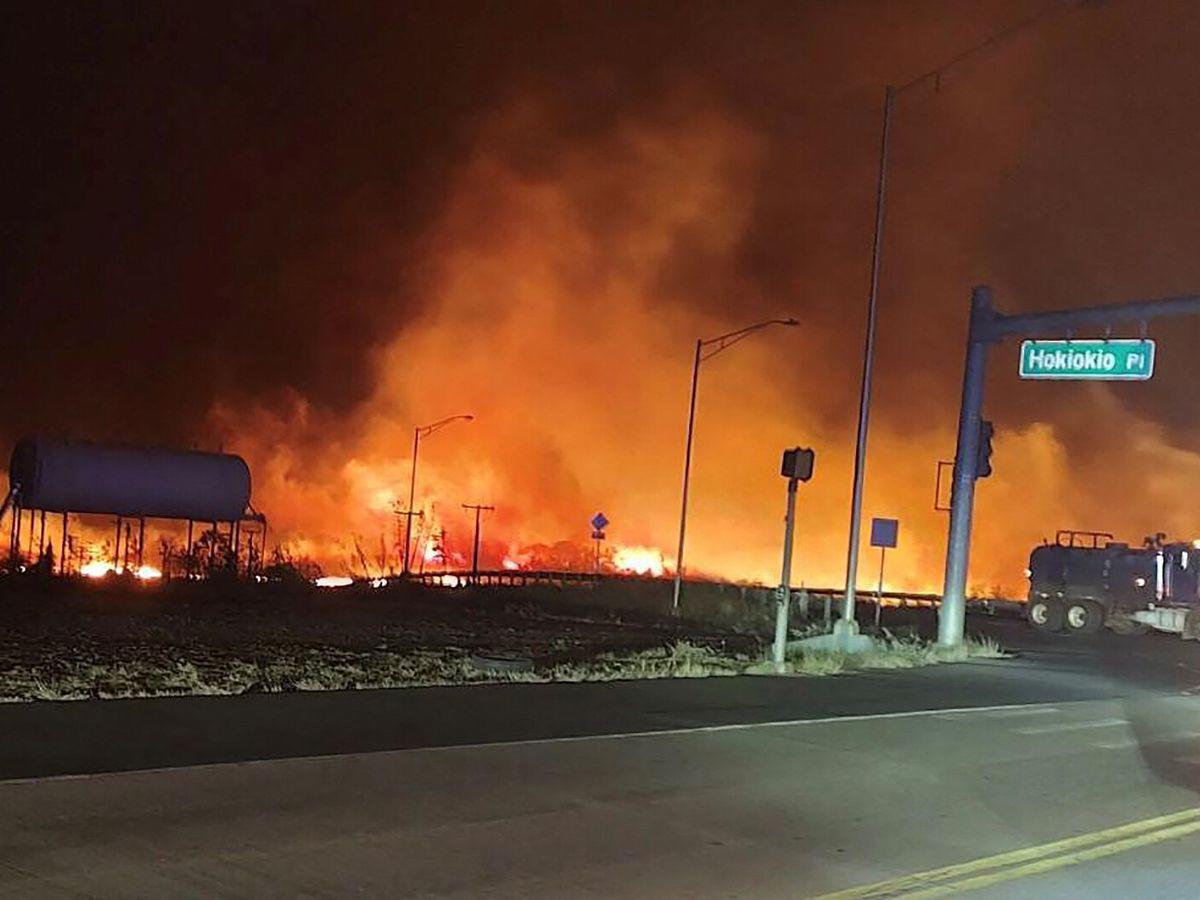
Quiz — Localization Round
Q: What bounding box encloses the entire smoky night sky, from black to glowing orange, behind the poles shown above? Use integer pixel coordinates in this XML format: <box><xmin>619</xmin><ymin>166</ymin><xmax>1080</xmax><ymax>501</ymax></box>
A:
<box><xmin>7</xmin><ymin>0</ymin><xmax>1200</xmax><ymax>593</ymax></box>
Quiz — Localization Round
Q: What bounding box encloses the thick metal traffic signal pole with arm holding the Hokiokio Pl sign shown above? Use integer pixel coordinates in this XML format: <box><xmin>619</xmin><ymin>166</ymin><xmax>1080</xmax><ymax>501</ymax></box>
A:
<box><xmin>937</xmin><ymin>286</ymin><xmax>1200</xmax><ymax>646</ymax></box>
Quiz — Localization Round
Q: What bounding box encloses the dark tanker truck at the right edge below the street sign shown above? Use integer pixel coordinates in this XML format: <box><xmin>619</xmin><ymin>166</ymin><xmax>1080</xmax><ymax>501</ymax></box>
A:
<box><xmin>1026</xmin><ymin>530</ymin><xmax>1200</xmax><ymax>640</ymax></box>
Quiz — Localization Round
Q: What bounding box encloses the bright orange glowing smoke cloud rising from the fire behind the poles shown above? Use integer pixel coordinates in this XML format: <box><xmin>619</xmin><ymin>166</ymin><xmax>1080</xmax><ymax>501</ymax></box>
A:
<box><xmin>204</xmin><ymin>88</ymin><xmax>1193</xmax><ymax>595</ymax></box>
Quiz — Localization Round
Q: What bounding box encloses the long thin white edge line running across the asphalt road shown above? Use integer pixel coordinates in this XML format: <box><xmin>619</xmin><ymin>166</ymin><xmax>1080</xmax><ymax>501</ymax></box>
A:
<box><xmin>0</xmin><ymin>700</ymin><xmax>1070</xmax><ymax>786</ymax></box>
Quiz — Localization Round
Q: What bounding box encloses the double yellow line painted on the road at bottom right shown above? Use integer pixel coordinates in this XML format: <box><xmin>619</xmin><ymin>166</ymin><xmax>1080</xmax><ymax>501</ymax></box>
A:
<box><xmin>820</xmin><ymin>808</ymin><xmax>1200</xmax><ymax>900</ymax></box>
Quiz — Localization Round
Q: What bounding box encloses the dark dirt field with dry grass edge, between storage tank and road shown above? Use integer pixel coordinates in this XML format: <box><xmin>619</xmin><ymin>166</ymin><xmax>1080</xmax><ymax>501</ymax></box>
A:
<box><xmin>0</xmin><ymin>576</ymin><xmax>761</xmax><ymax>700</ymax></box>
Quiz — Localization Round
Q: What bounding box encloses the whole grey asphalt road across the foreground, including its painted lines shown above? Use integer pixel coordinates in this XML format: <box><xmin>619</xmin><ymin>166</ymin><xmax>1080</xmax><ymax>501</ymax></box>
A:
<box><xmin>0</xmin><ymin>623</ymin><xmax>1200</xmax><ymax>898</ymax></box>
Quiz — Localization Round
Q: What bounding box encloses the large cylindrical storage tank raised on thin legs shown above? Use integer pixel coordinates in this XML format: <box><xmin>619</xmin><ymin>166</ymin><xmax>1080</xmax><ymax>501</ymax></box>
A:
<box><xmin>8</xmin><ymin>438</ymin><xmax>250</xmax><ymax>522</ymax></box>
